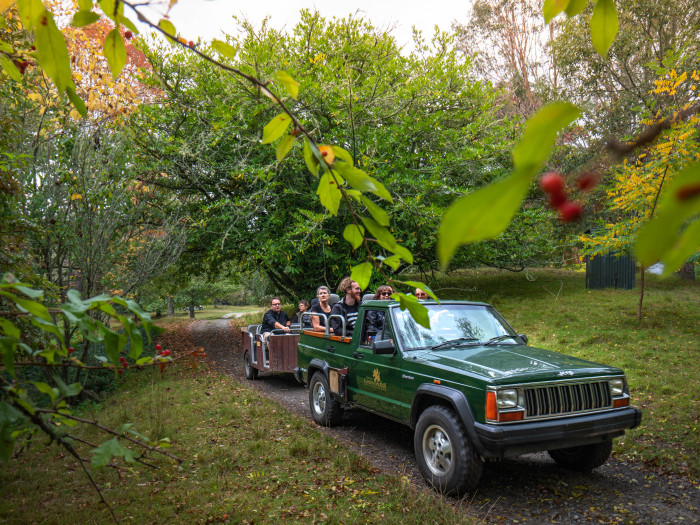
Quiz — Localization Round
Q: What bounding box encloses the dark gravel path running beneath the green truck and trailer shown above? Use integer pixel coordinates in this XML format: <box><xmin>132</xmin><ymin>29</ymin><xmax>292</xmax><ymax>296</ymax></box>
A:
<box><xmin>190</xmin><ymin>319</ymin><xmax>700</xmax><ymax>524</ymax></box>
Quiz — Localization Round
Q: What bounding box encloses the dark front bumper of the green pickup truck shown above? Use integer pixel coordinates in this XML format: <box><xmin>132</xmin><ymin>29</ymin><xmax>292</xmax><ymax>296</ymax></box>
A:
<box><xmin>474</xmin><ymin>407</ymin><xmax>642</xmax><ymax>457</ymax></box>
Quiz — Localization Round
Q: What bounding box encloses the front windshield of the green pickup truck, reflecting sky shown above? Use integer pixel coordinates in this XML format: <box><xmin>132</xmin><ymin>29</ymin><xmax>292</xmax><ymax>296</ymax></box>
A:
<box><xmin>394</xmin><ymin>304</ymin><xmax>520</xmax><ymax>350</ymax></box>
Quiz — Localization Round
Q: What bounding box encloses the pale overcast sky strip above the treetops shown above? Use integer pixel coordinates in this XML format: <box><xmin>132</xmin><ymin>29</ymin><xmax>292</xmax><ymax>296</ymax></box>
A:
<box><xmin>134</xmin><ymin>0</ymin><xmax>470</xmax><ymax>49</ymax></box>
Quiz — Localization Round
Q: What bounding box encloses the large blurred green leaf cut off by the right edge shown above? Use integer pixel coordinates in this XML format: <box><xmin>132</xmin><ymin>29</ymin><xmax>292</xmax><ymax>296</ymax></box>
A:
<box><xmin>636</xmin><ymin>163</ymin><xmax>700</xmax><ymax>271</ymax></box>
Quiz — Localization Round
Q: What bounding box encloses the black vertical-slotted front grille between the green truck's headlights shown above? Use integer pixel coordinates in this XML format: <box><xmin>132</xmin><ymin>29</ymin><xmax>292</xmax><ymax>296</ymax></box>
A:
<box><xmin>525</xmin><ymin>381</ymin><xmax>612</xmax><ymax>418</ymax></box>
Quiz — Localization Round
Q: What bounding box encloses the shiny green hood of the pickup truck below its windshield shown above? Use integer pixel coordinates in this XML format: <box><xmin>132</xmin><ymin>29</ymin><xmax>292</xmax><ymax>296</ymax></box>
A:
<box><xmin>414</xmin><ymin>345</ymin><xmax>623</xmax><ymax>383</ymax></box>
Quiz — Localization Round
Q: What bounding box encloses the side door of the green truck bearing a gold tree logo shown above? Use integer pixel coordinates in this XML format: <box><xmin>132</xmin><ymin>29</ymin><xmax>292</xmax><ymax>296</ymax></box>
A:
<box><xmin>348</xmin><ymin>309</ymin><xmax>410</xmax><ymax>420</ymax></box>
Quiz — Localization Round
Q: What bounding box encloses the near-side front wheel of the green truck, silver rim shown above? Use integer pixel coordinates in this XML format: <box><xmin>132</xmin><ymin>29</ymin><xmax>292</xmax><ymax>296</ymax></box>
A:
<box><xmin>413</xmin><ymin>406</ymin><xmax>484</xmax><ymax>496</ymax></box>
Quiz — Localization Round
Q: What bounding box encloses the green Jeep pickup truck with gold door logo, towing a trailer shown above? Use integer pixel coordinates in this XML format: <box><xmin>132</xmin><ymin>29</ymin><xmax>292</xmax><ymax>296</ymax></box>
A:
<box><xmin>294</xmin><ymin>301</ymin><xmax>641</xmax><ymax>495</ymax></box>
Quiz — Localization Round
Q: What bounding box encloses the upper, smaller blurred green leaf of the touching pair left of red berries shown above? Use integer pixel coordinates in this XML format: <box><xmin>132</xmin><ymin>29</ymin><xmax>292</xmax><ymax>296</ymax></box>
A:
<box><xmin>513</xmin><ymin>102</ymin><xmax>581</xmax><ymax>168</ymax></box>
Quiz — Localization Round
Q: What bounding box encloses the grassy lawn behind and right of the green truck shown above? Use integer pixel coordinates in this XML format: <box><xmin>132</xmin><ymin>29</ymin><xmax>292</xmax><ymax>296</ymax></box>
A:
<box><xmin>418</xmin><ymin>270</ymin><xmax>700</xmax><ymax>479</ymax></box>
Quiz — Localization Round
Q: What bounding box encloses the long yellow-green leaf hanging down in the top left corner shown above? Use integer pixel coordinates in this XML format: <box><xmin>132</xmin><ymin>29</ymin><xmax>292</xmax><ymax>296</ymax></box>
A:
<box><xmin>34</xmin><ymin>11</ymin><xmax>74</xmax><ymax>91</ymax></box>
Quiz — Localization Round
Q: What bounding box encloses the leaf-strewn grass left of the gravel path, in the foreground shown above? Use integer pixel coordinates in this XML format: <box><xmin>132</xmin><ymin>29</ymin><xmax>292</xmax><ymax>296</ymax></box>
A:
<box><xmin>0</xmin><ymin>363</ymin><xmax>476</xmax><ymax>524</ymax></box>
